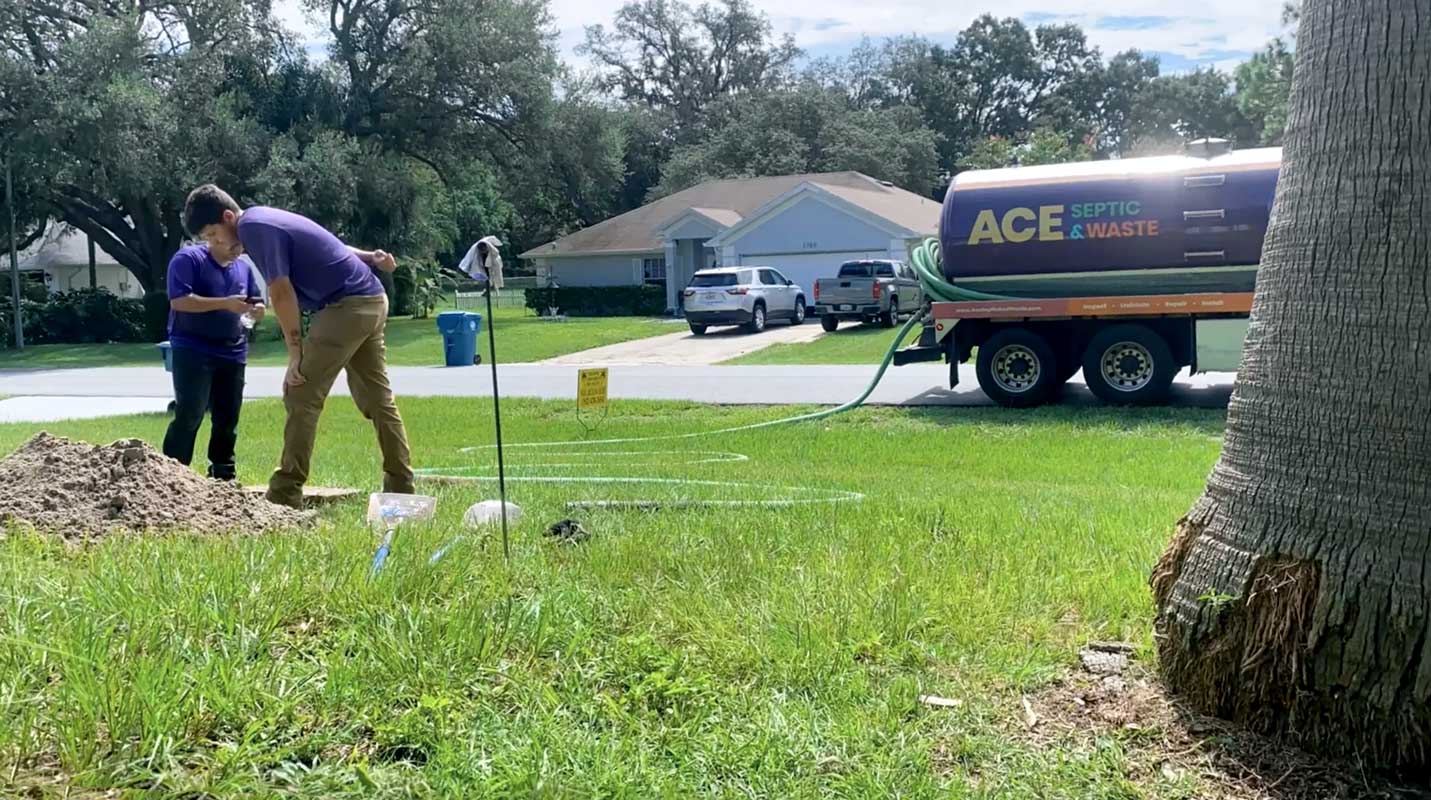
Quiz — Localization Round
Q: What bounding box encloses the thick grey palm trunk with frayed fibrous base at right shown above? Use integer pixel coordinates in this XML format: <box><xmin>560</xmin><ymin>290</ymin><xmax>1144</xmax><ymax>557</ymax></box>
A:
<box><xmin>1151</xmin><ymin>0</ymin><xmax>1431</xmax><ymax>766</ymax></box>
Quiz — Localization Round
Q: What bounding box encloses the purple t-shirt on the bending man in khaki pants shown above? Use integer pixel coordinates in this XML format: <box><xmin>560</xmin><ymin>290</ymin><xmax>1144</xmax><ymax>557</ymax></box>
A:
<box><xmin>239</xmin><ymin>206</ymin><xmax>382</xmax><ymax>311</ymax></box>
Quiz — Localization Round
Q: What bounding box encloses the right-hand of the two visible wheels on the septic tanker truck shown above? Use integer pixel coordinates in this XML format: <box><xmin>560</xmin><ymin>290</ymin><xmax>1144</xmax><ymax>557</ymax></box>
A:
<box><xmin>1083</xmin><ymin>325</ymin><xmax>1178</xmax><ymax>405</ymax></box>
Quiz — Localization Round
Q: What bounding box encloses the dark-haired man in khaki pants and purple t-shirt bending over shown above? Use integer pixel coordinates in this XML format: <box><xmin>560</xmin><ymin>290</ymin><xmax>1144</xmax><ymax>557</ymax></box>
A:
<box><xmin>183</xmin><ymin>185</ymin><xmax>414</xmax><ymax>508</ymax></box>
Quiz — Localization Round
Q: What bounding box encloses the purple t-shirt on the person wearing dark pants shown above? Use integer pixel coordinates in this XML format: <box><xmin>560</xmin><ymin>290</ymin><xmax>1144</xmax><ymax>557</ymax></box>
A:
<box><xmin>167</xmin><ymin>245</ymin><xmax>263</xmax><ymax>364</ymax></box>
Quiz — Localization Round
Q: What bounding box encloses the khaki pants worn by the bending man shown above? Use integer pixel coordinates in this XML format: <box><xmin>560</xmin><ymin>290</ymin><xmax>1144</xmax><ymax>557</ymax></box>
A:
<box><xmin>268</xmin><ymin>295</ymin><xmax>412</xmax><ymax>508</ymax></box>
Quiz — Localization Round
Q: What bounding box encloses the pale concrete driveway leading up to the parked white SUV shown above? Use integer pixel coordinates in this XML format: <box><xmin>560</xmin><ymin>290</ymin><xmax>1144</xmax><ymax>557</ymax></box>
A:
<box><xmin>541</xmin><ymin>321</ymin><xmax>824</xmax><ymax>366</ymax></box>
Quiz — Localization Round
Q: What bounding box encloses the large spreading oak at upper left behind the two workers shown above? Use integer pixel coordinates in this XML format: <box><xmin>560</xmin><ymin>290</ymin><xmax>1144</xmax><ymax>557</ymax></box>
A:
<box><xmin>0</xmin><ymin>0</ymin><xmax>558</xmax><ymax>292</ymax></box>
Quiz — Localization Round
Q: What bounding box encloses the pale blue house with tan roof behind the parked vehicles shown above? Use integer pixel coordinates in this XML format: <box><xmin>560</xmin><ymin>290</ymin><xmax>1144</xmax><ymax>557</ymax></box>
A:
<box><xmin>521</xmin><ymin>172</ymin><xmax>940</xmax><ymax>309</ymax></box>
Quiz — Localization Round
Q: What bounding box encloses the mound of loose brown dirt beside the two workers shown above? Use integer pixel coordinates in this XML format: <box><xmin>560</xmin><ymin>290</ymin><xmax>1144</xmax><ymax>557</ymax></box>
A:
<box><xmin>0</xmin><ymin>432</ymin><xmax>312</xmax><ymax>540</ymax></box>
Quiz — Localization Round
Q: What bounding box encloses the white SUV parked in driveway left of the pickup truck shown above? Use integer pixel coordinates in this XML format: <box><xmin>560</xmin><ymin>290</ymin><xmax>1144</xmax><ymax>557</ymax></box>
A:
<box><xmin>683</xmin><ymin>266</ymin><xmax>806</xmax><ymax>336</ymax></box>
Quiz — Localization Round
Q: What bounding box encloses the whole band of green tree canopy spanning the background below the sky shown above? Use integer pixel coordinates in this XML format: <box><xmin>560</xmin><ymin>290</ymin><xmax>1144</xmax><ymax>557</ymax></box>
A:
<box><xmin>0</xmin><ymin>0</ymin><xmax>1295</xmax><ymax>289</ymax></box>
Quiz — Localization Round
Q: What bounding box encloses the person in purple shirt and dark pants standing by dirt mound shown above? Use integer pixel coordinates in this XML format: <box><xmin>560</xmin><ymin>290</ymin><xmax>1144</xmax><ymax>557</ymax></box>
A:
<box><xmin>165</xmin><ymin>245</ymin><xmax>263</xmax><ymax>481</ymax></box>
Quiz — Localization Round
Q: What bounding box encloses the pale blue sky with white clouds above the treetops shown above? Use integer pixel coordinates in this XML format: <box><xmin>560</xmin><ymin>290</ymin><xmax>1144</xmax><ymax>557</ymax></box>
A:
<box><xmin>275</xmin><ymin>0</ymin><xmax>1282</xmax><ymax>72</ymax></box>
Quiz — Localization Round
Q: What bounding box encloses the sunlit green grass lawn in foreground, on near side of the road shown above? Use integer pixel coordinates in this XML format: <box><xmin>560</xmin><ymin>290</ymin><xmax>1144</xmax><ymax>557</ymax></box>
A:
<box><xmin>0</xmin><ymin>399</ymin><xmax>1222</xmax><ymax>799</ymax></box>
